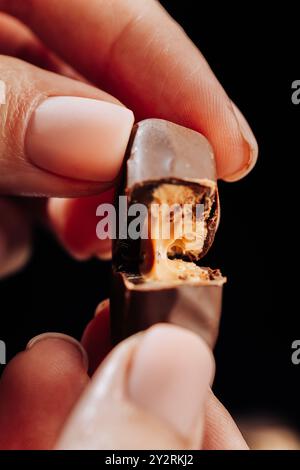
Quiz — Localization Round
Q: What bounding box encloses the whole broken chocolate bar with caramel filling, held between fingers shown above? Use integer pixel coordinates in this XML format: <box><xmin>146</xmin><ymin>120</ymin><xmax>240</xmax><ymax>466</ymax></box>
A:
<box><xmin>111</xmin><ymin>119</ymin><xmax>225</xmax><ymax>347</ymax></box>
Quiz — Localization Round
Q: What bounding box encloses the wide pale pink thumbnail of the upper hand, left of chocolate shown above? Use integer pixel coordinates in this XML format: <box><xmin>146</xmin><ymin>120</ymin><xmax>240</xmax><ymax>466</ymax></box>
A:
<box><xmin>25</xmin><ymin>96</ymin><xmax>134</xmax><ymax>182</ymax></box>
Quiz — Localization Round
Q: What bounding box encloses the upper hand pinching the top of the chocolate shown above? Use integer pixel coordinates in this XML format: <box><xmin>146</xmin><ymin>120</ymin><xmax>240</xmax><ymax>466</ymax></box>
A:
<box><xmin>0</xmin><ymin>0</ymin><xmax>257</xmax><ymax>276</ymax></box>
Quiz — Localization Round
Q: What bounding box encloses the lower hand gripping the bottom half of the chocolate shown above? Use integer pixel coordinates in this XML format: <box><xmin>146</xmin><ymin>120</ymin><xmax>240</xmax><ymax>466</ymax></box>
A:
<box><xmin>0</xmin><ymin>303</ymin><xmax>247</xmax><ymax>450</ymax></box>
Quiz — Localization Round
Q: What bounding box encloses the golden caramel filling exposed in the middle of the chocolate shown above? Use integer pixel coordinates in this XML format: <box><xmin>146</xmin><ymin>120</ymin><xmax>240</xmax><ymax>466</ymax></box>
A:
<box><xmin>140</xmin><ymin>183</ymin><xmax>210</xmax><ymax>282</ymax></box>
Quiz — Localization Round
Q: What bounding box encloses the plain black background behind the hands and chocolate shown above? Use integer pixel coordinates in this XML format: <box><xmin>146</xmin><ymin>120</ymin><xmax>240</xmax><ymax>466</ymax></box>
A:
<box><xmin>0</xmin><ymin>0</ymin><xmax>300</xmax><ymax>425</ymax></box>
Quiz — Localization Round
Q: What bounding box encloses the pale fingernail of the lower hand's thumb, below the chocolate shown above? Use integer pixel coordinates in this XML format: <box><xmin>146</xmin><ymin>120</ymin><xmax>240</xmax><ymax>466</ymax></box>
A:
<box><xmin>128</xmin><ymin>325</ymin><xmax>214</xmax><ymax>437</ymax></box>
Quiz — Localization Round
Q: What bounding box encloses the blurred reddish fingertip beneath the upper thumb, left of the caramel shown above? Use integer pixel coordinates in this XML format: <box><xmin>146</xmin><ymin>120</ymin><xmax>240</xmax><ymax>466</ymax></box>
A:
<box><xmin>47</xmin><ymin>189</ymin><xmax>114</xmax><ymax>260</ymax></box>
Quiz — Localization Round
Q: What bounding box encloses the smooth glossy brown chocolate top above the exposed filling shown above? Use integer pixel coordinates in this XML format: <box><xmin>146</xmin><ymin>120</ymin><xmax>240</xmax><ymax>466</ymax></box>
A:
<box><xmin>126</xmin><ymin>119</ymin><xmax>216</xmax><ymax>188</ymax></box>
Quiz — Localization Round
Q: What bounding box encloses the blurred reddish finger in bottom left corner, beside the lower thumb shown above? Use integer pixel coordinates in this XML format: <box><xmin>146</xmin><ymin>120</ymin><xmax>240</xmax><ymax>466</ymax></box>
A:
<box><xmin>0</xmin><ymin>333</ymin><xmax>89</xmax><ymax>449</ymax></box>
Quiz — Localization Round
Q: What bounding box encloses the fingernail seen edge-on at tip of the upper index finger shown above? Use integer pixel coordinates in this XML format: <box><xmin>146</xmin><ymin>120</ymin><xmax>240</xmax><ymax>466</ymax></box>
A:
<box><xmin>223</xmin><ymin>101</ymin><xmax>258</xmax><ymax>182</ymax></box>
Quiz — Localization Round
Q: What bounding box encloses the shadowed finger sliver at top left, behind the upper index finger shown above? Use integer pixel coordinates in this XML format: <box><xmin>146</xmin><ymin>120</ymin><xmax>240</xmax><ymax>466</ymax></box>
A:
<box><xmin>0</xmin><ymin>13</ymin><xmax>79</xmax><ymax>78</ymax></box>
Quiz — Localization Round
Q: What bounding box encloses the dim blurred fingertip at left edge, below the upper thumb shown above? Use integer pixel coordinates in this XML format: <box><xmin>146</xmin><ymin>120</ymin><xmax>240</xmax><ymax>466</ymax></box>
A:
<box><xmin>0</xmin><ymin>198</ymin><xmax>31</xmax><ymax>279</ymax></box>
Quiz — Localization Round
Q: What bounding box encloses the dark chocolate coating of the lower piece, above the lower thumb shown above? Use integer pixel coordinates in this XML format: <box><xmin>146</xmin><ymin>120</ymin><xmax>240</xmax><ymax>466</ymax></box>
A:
<box><xmin>110</xmin><ymin>272</ymin><xmax>224</xmax><ymax>348</ymax></box>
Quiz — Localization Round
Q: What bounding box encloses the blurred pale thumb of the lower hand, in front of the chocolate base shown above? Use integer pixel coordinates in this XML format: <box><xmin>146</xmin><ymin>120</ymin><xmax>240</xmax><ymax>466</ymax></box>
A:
<box><xmin>56</xmin><ymin>324</ymin><xmax>214</xmax><ymax>449</ymax></box>
